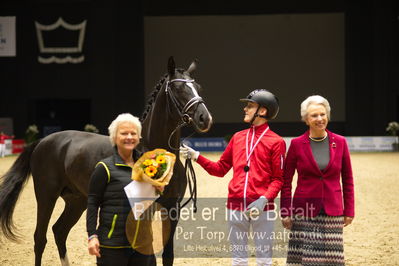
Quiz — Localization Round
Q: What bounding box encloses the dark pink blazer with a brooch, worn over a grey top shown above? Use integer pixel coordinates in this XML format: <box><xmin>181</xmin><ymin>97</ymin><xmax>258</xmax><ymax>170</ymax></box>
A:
<box><xmin>280</xmin><ymin>131</ymin><xmax>355</xmax><ymax>217</ymax></box>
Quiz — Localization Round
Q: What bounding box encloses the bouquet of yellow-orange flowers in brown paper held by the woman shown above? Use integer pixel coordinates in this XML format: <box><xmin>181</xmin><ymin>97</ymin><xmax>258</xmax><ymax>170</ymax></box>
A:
<box><xmin>132</xmin><ymin>149</ymin><xmax>176</xmax><ymax>186</ymax></box>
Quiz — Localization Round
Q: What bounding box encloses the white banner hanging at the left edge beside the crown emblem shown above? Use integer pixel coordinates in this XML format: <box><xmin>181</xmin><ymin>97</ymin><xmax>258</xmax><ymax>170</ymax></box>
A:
<box><xmin>0</xmin><ymin>17</ymin><xmax>16</xmax><ymax>56</ymax></box>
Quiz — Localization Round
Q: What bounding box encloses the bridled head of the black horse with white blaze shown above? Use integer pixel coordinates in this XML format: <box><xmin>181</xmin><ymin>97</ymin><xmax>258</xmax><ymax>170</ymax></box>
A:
<box><xmin>166</xmin><ymin>56</ymin><xmax>212</xmax><ymax>133</ymax></box>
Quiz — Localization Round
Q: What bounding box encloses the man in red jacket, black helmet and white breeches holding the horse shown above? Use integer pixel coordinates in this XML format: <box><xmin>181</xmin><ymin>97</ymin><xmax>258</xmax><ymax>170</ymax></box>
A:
<box><xmin>180</xmin><ymin>90</ymin><xmax>286</xmax><ymax>265</ymax></box>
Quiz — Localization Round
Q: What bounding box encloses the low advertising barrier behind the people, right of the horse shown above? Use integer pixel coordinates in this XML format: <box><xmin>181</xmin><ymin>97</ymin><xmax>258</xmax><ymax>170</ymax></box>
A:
<box><xmin>182</xmin><ymin>136</ymin><xmax>398</xmax><ymax>152</ymax></box>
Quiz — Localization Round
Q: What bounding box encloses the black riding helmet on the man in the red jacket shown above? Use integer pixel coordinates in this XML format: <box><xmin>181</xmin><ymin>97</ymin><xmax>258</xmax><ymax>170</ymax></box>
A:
<box><xmin>240</xmin><ymin>89</ymin><xmax>279</xmax><ymax>120</ymax></box>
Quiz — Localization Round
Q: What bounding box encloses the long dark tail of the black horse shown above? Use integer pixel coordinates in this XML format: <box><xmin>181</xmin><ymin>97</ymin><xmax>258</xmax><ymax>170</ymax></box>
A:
<box><xmin>0</xmin><ymin>141</ymin><xmax>39</xmax><ymax>241</ymax></box>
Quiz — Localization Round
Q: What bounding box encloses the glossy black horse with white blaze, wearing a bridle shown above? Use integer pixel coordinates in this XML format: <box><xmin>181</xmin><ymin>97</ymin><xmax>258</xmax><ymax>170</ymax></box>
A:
<box><xmin>0</xmin><ymin>57</ymin><xmax>212</xmax><ymax>265</ymax></box>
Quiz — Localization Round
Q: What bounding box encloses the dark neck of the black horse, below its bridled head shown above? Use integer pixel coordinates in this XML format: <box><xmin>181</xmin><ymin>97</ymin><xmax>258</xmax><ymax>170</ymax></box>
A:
<box><xmin>142</xmin><ymin>88</ymin><xmax>180</xmax><ymax>152</ymax></box>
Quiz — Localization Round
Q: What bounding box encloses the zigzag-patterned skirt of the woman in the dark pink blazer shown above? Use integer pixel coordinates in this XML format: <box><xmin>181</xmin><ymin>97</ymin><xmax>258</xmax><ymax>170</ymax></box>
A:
<box><xmin>287</xmin><ymin>214</ymin><xmax>345</xmax><ymax>266</ymax></box>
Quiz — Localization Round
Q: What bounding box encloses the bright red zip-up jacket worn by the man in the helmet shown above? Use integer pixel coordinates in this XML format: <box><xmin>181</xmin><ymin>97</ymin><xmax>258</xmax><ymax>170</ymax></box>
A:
<box><xmin>197</xmin><ymin>123</ymin><xmax>286</xmax><ymax>210</ymax></box>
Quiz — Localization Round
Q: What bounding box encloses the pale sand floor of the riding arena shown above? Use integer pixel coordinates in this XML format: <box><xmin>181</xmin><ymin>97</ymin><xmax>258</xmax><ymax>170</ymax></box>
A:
<box><xmin>0</xmin><ymin>153</ymin><xmax>399</xmax><ymax>266</ymax></box>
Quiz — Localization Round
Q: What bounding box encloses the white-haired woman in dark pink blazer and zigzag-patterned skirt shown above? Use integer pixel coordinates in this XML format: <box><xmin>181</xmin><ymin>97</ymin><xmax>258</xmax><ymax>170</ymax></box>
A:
<box><xmin>281</xmin><ymin>95</ymin><xmax>355</xmax><ymax>265</ymax></box>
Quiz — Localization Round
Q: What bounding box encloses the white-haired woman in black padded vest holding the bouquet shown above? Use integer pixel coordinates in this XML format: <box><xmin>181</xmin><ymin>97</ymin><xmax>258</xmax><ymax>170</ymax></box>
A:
<box><xmin>86</xmin><ymin>113</ymin><xmax>163</xmax><ymax>265</ymax></box>
